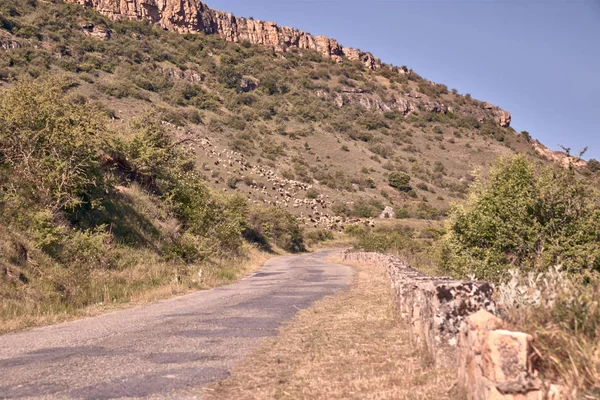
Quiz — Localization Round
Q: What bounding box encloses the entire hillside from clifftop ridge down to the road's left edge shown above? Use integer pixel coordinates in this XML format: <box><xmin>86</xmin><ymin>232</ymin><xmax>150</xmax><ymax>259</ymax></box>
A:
<box><xmin>0</xmin><ymin>0</ymin><xmax>591</xmax><ymax>328</ymax></box>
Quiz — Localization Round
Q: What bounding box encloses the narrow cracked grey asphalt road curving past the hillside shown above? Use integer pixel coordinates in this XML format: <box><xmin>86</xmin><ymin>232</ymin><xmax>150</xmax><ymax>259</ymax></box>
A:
<box><xmin>0</xmin><ymin>251</ymin><xmax>353</xmax><ymax>399</ymax></box>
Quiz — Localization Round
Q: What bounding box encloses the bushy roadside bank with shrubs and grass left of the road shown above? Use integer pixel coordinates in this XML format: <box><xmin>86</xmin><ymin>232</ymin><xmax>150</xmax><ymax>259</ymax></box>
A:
<box><xmin>0</xmin><ymin>78</ymin><xmax>304</xmax><ymax>328</ymax></box>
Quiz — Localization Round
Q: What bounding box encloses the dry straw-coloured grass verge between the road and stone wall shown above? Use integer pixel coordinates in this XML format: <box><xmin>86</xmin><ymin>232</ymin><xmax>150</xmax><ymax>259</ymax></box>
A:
<box><xmin>205</xmin><ymin>255</ymin><xmax>455</xmax><ymax>399</ymax></box>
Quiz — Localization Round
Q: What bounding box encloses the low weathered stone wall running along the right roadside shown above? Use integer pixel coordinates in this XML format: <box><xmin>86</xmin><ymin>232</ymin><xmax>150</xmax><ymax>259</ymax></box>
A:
<box><xmin>343</xmin><ymin>252</ymin><xmax>560</xmax><ymax>400</ymax></box>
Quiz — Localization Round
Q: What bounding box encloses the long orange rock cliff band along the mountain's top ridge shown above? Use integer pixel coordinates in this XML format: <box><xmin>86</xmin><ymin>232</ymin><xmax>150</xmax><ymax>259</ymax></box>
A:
<box><xmin>67</xmin><ymin>0</ymin><xmax>382</xmax><ymax>72</ymax></box>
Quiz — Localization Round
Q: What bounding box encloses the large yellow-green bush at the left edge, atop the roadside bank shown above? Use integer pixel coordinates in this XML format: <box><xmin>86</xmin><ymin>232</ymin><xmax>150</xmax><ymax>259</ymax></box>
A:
<box><xmin>0</xmin><ymin>78</ymin><xmax>111</xmax><ymax>211</ymax></box>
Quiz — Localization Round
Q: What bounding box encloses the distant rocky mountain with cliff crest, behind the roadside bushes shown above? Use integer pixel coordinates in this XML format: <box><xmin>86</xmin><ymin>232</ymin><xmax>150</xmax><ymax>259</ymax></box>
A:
<box><xmin>0</xmin><ymin>0</ymin><xmax>592</xmax><ymax>227</ymax></box>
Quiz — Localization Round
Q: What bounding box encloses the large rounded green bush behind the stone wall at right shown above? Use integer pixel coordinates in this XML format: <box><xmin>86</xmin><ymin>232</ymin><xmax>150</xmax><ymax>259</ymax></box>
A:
<box><xmin>442</xmin><ymin>156</ymin><xmax>600</xmax><ymax>280</ymax></box>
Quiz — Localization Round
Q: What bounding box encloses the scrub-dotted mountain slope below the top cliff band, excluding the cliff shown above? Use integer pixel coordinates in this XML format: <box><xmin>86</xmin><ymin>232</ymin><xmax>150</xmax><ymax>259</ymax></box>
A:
<box><xmin>0</xmin><ymin>0</ymin><xmax>548</xmax><ymax>222</ymax></box>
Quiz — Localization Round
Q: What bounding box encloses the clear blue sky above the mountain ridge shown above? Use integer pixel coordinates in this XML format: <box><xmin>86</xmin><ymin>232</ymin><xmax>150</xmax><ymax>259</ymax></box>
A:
<box><xmin>205</xmin><ymin>0</ymin><xmax>600</xmax><ymax>159</ymax></box>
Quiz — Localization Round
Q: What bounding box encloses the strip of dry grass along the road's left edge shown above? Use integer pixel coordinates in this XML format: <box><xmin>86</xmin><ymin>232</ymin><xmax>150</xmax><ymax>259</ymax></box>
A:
<box><xmin>0</xmin><ymin>248</ymin><xmax>278</xmax><ymax>334</ymax></box>
